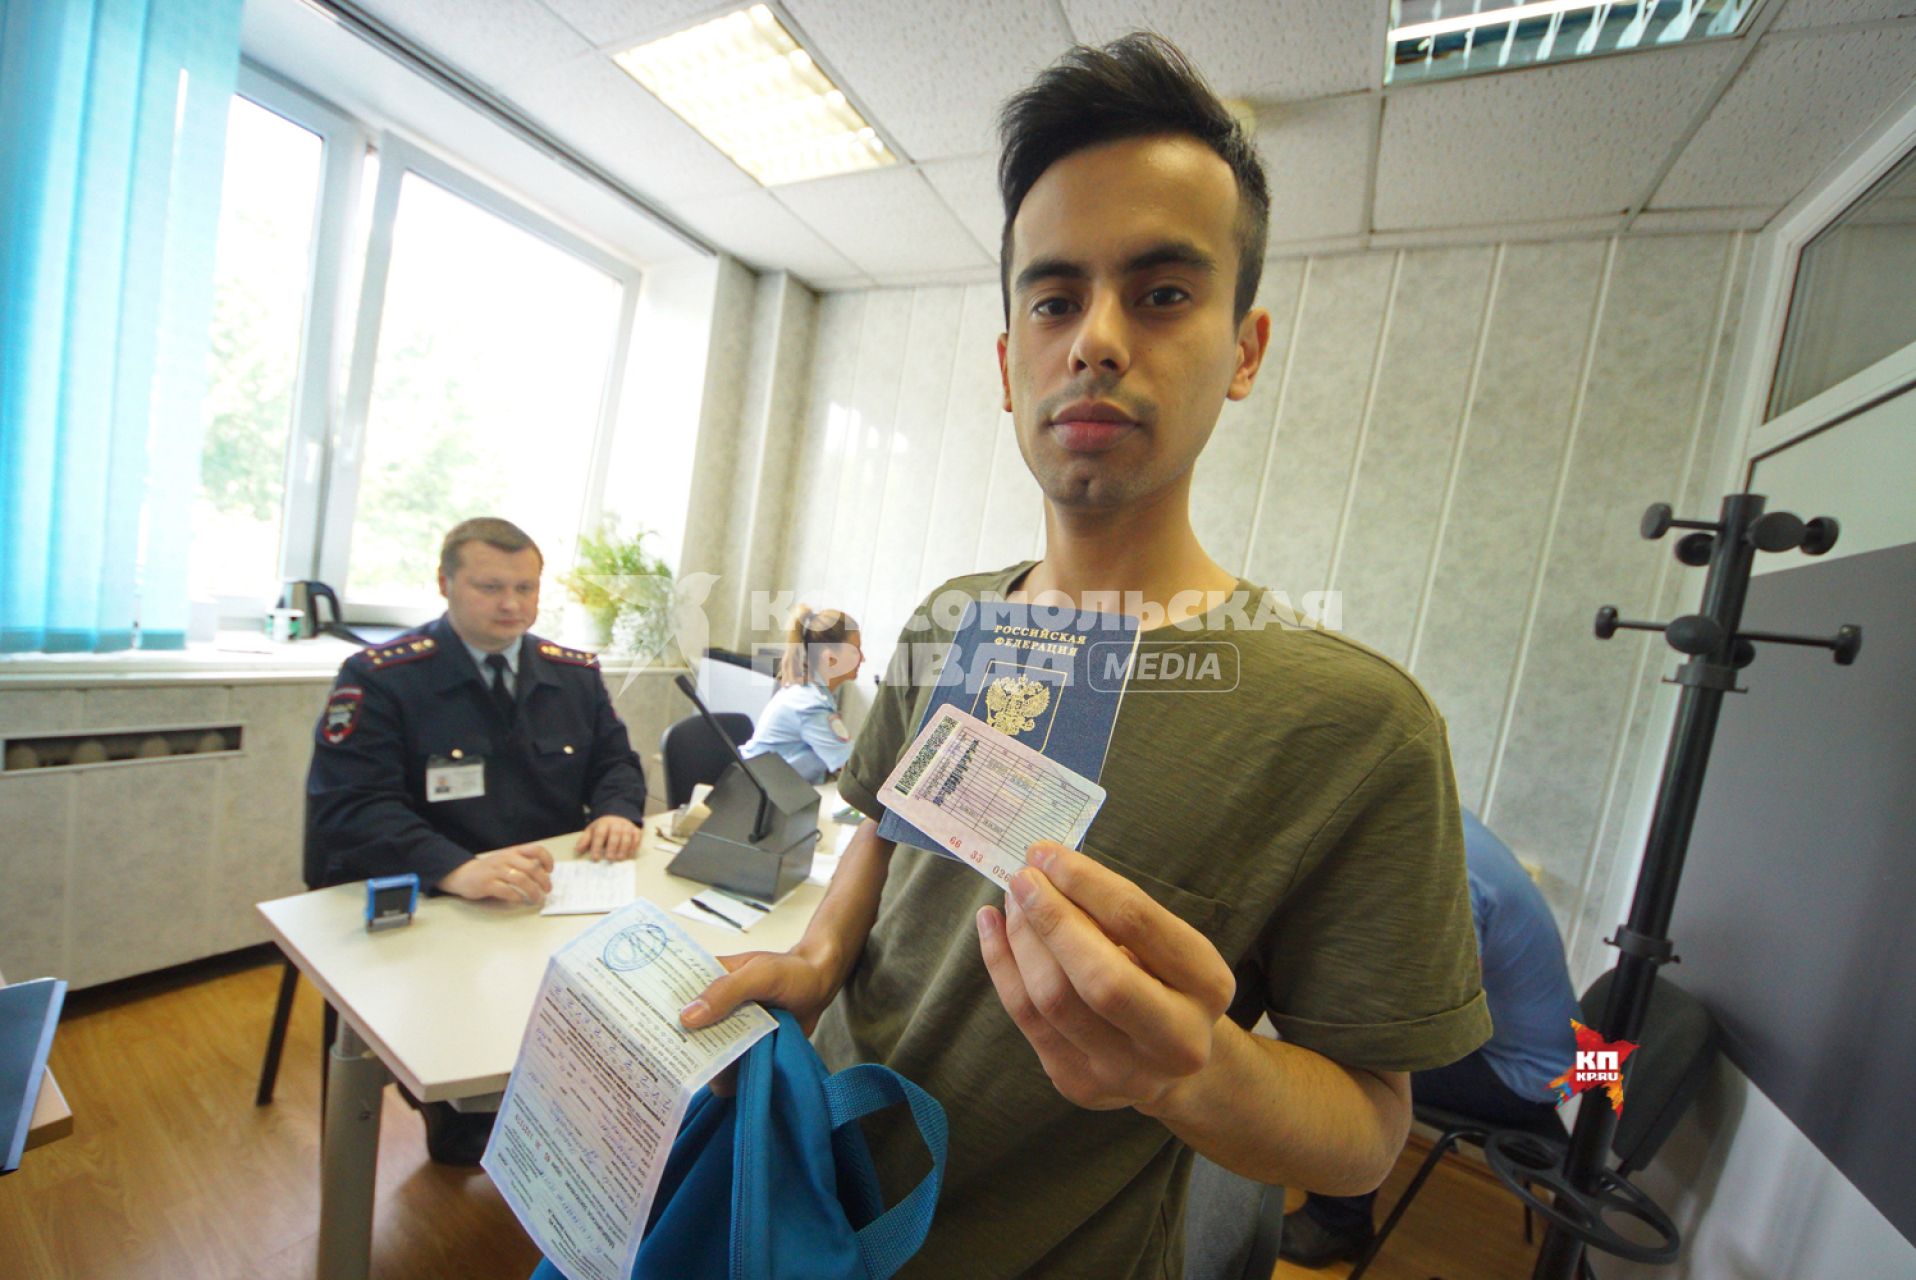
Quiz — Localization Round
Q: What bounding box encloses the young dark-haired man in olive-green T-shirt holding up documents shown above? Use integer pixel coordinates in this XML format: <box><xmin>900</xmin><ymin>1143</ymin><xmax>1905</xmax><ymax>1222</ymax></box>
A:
<box><xmin>684</xmin><ymin>34</ymin><xmax>1489</xmax><ymax>1278</ymax></box>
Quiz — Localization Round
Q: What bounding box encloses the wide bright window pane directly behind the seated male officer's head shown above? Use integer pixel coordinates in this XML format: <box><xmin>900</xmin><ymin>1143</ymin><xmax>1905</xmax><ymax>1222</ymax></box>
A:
<box><xmin>347</xmin><ymin>174</ymin><xmax>621</xmax><ymax>613</ymax></box>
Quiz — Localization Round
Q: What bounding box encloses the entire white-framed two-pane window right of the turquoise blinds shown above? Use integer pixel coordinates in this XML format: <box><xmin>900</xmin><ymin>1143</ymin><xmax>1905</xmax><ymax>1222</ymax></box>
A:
<box><xmin>192</xmin><ymin>67</ymin><xmax>638</xmax><ymax>623</ymax></box>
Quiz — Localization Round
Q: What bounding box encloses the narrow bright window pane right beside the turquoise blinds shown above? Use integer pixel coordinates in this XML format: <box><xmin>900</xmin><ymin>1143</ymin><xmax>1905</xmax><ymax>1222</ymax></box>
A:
<box><xmin>190</xmin><ymin>98</ymin><xmax>324</xmax><ymax>604</ymax></box>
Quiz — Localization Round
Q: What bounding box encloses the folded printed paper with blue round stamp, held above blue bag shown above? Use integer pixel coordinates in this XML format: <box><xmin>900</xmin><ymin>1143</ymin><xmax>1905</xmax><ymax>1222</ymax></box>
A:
<box><xmin>479</xmin><ymin>901</ymin><xmax>776</xmax><ymax>1280</ymax></box>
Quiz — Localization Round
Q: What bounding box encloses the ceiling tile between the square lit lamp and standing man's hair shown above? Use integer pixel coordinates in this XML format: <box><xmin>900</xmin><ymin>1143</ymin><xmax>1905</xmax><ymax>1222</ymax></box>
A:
<box><xmin>772</xmin><ymin>167</ymin><xmax>991</xmax><ymax>284</ymax></box>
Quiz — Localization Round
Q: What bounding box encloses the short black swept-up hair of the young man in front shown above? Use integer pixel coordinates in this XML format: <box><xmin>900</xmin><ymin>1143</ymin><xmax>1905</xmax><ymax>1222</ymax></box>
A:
<box><xmin>998</xmin><ymin>31</ymin><xmax>1270</xmax><ymax>324</ymax></box>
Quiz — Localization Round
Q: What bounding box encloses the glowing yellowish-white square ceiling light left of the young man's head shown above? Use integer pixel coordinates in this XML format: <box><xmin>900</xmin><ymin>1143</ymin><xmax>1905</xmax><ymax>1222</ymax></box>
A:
<box><xmin>613</xmin><ymin>4</ymin><xmax>897</xmax><ymax>186</ymax></box>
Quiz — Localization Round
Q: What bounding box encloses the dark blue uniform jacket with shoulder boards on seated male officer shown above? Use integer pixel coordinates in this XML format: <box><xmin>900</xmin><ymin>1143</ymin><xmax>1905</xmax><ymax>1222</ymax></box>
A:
<box><xmin>305</xmin><ymin>617</ymin><xmax>646</xmax><ymax>887</ymax></box>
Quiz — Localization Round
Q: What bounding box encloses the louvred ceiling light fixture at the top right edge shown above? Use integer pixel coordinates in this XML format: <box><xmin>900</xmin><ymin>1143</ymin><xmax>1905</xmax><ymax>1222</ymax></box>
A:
<box><xmin>1383</xmin><ymin>0</ymin><xmax>1763</xmax><ymax>84</ymax></box>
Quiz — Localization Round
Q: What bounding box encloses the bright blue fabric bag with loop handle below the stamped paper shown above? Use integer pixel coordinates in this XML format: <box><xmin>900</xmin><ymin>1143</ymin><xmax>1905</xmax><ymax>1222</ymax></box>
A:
<box><xmin>533</xmin><ymin>1010</ymin><xmax>945</xmax><ymax>1280</ymax></box>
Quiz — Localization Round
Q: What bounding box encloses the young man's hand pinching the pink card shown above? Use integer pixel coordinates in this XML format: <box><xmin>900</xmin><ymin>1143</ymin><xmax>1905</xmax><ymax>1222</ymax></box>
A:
<box><xmin>977</xmin><ymin>843</ymin><xmax>1236</xmax><ymax>1111</ymax></box>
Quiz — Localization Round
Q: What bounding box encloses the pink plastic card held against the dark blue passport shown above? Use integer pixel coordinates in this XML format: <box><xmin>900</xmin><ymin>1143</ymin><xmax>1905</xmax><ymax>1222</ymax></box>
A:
<box><xmin>878</xmin><ymin>705</ymin><xmax>1104</xmax><ymax>887</ymax></box>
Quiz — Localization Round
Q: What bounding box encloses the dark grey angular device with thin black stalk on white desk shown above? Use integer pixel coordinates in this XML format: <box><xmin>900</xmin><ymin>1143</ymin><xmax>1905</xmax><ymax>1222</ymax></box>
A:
<box><xmin>665</xmin><ymin>676</ymin><xmax>818</xmax><ymax>903</ymax></box>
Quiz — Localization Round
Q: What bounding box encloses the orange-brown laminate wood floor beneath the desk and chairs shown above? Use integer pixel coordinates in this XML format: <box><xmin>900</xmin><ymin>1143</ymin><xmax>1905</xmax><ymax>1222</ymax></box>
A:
<box><xmin>0</xmin><ymin>952</ymin><xmax>1533</xmax><ymax>1280</ymax></box>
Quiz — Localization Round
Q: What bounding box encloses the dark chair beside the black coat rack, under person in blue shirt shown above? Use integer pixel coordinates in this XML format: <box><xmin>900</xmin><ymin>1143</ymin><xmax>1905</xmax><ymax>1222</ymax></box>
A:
<box><xmin>1349</xmin><ymin>971</ymin><xmax>1717</xmax><ymax>1280</ymax></box>
